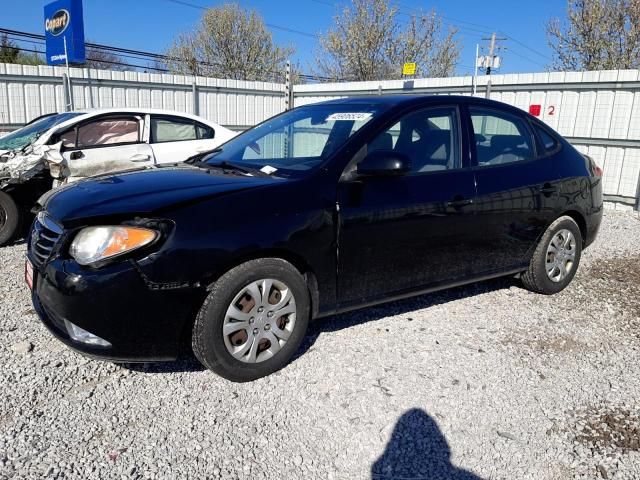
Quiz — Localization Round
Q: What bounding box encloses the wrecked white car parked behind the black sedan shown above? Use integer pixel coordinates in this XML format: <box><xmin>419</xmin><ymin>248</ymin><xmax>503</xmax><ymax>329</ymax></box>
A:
<box><xmin>0</xmin><ymin>108</ymin><xmax>236</xmax><ymax>246</ymax></box>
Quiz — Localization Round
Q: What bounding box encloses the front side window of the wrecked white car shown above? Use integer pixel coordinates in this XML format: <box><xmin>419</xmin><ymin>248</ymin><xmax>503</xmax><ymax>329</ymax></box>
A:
<box><xmin>75</xmin><ymin>118</ymin><xmax>140</xmax><ymax>148</ymax></box>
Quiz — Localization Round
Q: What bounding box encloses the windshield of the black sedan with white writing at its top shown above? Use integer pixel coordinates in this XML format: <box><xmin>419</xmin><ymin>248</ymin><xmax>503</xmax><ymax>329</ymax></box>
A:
<box><xmin>204</xmin><ymin>104</ymin><xmax>383</xmax><ymax>176</ymax></box>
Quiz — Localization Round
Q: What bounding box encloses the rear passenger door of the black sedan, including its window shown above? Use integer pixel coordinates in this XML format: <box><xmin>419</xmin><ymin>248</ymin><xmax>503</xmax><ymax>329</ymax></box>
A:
<box><xmin>469</xmin><ymin>105</ymin><xmax>559</xmax><ymax>273</ymax></box>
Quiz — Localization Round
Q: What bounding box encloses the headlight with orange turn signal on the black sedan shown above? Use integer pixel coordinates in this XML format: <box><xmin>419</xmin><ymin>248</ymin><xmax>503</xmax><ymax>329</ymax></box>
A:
<box><xmin>69</xmin><ymin>226</ymin><xmax>158</xmax><ymax>265</ymax></box>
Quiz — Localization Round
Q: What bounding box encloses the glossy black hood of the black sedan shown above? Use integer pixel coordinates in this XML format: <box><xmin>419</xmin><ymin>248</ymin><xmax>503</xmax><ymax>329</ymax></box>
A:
<box><xmin>38</xmin><ymin>166</ymin><xmax>286</xmax><ymax>225</ymax></box>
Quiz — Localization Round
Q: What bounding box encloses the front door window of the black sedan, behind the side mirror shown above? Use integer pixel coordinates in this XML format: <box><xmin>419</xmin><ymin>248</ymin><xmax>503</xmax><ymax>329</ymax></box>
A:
<box><xmin>367</xmin><ymin>107</ymin><xmax>460</xmax><ymax>174</ymax></box>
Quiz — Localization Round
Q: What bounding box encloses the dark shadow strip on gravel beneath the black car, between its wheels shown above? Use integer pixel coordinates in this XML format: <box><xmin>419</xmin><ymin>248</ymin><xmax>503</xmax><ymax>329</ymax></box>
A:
<box><xmin>292</xmin><ymin>277</ymin><xmax>520</xmax><ymax>361</ymax></box>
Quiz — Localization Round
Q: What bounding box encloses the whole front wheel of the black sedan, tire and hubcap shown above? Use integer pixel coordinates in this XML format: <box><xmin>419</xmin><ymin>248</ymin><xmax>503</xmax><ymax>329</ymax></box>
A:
<box><xmin>192</xmin><ymin>258</ymin><xmax>311</xmax><ymax>382</ymax></box>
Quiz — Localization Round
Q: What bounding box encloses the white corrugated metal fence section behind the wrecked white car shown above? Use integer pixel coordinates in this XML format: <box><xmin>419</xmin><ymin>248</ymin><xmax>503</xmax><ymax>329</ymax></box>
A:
<box><xmin>0</xmin><ymin>64</ymin><xmax>285</xmax><ymax>131</ymax></box>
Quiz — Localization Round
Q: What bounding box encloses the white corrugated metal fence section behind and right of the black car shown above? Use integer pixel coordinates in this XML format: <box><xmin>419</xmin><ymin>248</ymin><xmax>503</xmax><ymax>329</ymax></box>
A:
<box><xmin>294</xmin><ymin>70</ymin><xmax>640</xmax><ymax>209</ymax></box>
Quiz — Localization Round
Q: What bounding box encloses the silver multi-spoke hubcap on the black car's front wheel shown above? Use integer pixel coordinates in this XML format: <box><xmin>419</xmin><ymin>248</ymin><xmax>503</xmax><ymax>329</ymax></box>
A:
<box><xmin>222</xmin><ymin>278</ymin><xmax>296</xmax><ymax>363</ymax></box>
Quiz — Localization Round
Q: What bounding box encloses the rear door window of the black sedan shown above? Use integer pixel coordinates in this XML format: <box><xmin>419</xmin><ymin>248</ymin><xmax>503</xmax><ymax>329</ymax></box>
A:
<box><xmin>470</xmin><ymin>108</ymin><xmax>535</xmax><ymax>167</ymax></box>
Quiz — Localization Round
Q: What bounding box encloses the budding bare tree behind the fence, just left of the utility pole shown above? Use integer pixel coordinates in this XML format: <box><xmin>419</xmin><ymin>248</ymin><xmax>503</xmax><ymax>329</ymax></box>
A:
<box><xmin>317</xmin><ymin>0</ymin><xmax>460</xmax><ymax>80</ymax></box>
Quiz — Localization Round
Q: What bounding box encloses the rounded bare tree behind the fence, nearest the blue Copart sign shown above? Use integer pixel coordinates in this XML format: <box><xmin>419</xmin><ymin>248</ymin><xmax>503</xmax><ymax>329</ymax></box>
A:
<box><xmin>166</xmin><ymin>4</ymin><xmax>293</xmax><ymax>81</ymax></box>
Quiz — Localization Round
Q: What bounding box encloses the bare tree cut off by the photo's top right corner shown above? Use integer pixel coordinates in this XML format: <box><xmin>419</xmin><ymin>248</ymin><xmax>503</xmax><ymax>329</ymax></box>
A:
<box><xmin>547</xmin><ymin>0</ymin><xmax>640</xmax><ymax>70</ymax></box>
